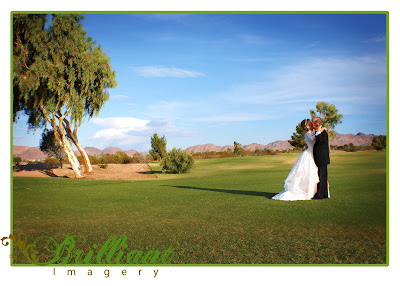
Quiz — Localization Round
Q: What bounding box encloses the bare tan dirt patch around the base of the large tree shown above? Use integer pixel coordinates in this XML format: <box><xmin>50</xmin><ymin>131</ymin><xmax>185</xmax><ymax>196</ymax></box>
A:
<box><xmin>13</xmin><ymin>163</ymin><xmax>157</xmax><ymax>180</ymax></box>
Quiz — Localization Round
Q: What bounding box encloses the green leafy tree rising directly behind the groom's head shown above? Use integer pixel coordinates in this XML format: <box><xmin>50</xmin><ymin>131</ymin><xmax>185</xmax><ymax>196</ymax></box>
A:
<box><xmin>310</xmin><ymin>101</ymin><xmax>343</xmax><ymax>139</ymax></box>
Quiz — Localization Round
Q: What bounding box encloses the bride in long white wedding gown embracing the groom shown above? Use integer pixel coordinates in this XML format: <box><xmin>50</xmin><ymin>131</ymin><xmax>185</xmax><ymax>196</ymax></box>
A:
<box><xmin>272</xmin><ymin>132</ymin><xmax>319</xmax><ymax>201</ymax></box>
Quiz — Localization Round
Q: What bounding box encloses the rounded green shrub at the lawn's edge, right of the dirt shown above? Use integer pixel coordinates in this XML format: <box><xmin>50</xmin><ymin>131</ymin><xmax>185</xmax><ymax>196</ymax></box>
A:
<box><xmin>161</xmin><ymin>148</ymin><xmax>194</xmax><ymax>174</ymax></box>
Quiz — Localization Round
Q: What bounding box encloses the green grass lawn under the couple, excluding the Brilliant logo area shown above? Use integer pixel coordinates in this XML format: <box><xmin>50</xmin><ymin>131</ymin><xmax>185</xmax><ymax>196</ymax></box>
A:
<box><xmin>13</xmin><ymin>151</ymin><xmax>387</xmax><ymax>264</ymax></box>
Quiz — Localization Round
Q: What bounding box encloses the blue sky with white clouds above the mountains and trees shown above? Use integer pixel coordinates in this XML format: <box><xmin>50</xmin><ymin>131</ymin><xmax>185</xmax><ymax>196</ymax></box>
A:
<box><xmin>13</xmin><ymin>14</ymin><xmax>387</xmax><ymax>151</ymax></box>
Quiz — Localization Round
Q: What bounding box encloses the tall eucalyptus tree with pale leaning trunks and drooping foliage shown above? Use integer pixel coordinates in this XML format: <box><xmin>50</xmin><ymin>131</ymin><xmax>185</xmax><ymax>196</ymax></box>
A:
<box><xmin>13</xmin><ymin>14</ymin><xmax>117</xmax><ymax>178</ymax></box>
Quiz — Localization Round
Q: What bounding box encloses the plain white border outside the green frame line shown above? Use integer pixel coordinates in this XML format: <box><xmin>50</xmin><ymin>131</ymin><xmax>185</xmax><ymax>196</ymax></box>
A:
<box><xmin>0</xmin><ymin>0</ymin><xmax>400</xmax><ymax>286</ymax></box>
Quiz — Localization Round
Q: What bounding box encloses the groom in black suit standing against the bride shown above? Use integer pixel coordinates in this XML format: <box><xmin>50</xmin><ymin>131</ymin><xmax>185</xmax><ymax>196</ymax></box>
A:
<box><xmin>312</xmin><ymin>117</ymin><xmax>330</xmax><ymax>199</ymax></box>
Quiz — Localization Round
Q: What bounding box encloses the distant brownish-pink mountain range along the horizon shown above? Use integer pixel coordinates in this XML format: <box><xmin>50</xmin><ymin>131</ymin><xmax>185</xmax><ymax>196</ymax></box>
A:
<box><xmin>13</xmin><ymin>132</ymin><xmax>376</xmax><ymax>160</ymax></box>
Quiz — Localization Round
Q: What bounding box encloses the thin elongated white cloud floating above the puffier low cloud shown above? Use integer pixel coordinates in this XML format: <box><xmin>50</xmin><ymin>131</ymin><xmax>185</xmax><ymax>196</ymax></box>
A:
<box><xmin>131</xmin><ymin>66</ymin><xmax>204</xmax><ymax>78</ymax></box>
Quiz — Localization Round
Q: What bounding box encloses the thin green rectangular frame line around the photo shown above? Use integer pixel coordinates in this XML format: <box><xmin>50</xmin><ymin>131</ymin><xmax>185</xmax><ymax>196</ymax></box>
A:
<box><xmin>10</xmin><ymin>11</ymin><xmax>389</xmax><ymax>267</ymax></box>
